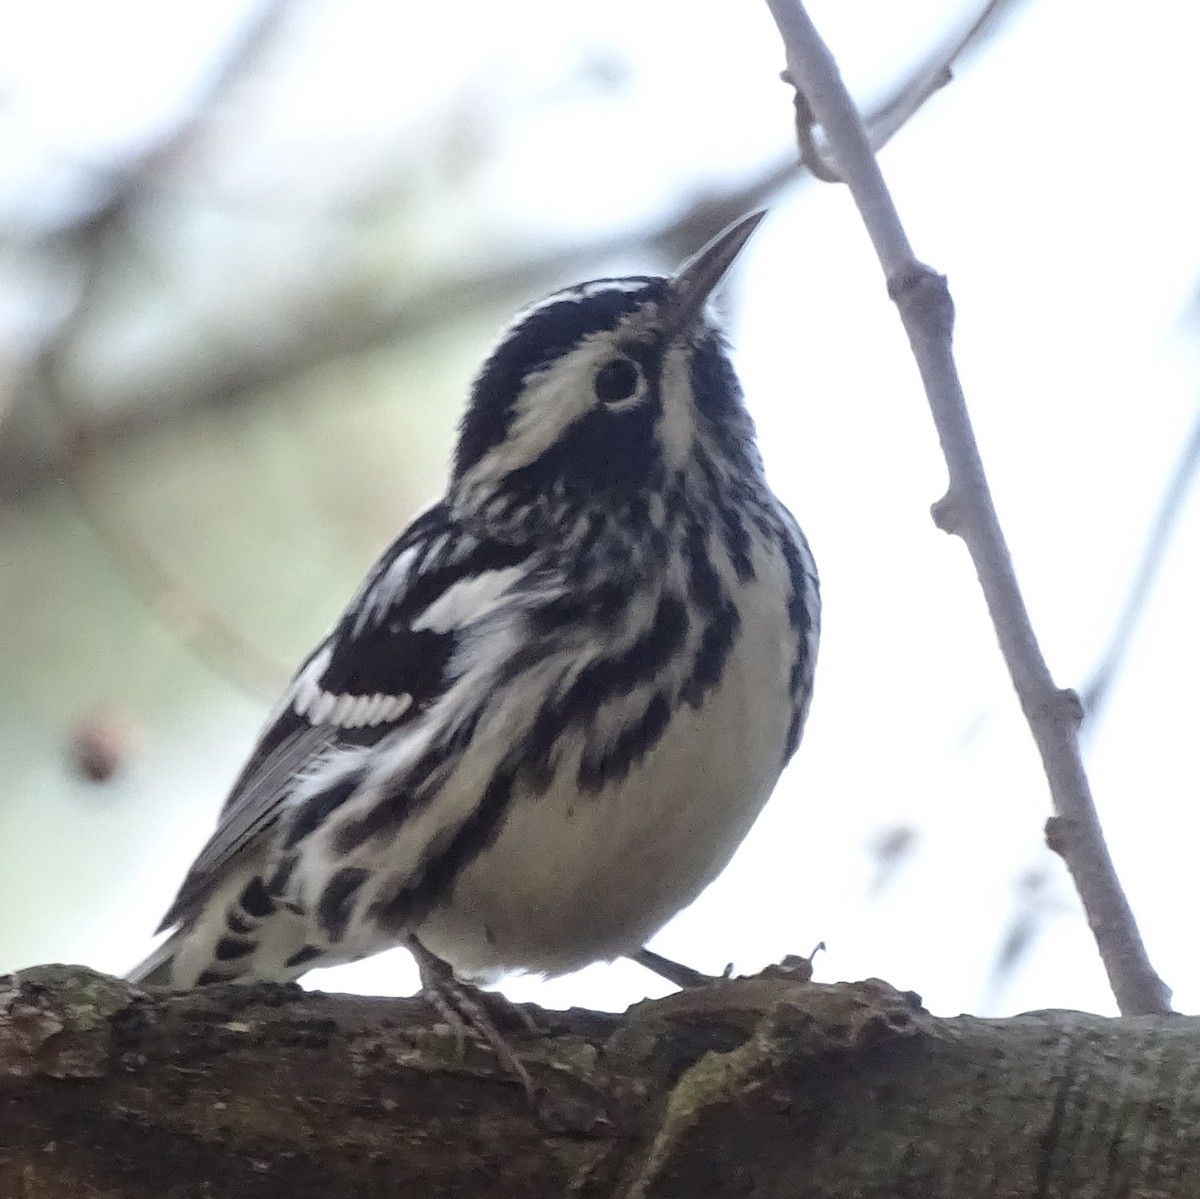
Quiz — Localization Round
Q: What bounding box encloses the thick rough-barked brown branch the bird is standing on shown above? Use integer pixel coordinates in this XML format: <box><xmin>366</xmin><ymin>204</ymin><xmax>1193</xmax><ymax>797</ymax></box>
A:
<box><xmin>0</xmin><ymin>966</ymin><xmax>1200</xmax><ymax>1199</ymax></box>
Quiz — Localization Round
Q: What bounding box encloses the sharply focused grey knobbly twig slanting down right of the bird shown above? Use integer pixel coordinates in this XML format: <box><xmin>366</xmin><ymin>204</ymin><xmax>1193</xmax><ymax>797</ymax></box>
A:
<box><xmin>767</xmin><ymin>0</ymin><xmax>1170</xmax><ymax>1015</ymax></box>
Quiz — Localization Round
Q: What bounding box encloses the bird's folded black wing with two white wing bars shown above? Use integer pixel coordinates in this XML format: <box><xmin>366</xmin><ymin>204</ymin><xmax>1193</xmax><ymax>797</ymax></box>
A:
<box><xmin>160</xmin><ymin>504</ymin><xmax>527</xmax><ymax>930</ymax></box>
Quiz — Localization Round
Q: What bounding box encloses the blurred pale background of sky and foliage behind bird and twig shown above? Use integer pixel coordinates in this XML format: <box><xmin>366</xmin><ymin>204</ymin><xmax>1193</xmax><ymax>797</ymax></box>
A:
<box><xmin>0</xmin><ymin>0</ymin><xmax>1200</xmax><ymax>1013</ymax></box>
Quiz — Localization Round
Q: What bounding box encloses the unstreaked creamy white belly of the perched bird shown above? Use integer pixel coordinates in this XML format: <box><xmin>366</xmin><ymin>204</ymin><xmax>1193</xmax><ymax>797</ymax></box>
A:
<box><xmin>418</xmin><ymin>584</ymin><xmax>794</xmax><ymax>977</ymax></box>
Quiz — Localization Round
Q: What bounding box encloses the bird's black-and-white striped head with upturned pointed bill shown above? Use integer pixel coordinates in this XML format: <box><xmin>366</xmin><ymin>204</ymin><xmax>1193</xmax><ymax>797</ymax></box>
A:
<box><xmin>452</xmin><ymin>212</ymin><xmax>763</xmax><ymax>532</ymax></box>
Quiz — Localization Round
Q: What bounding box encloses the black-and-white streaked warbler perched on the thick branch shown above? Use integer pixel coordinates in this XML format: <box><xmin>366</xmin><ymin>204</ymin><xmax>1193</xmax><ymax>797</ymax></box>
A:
<box><xmin>131</xmin><ymin>214</ymin><xmax>820</xmax><ymax>988</ymax></box>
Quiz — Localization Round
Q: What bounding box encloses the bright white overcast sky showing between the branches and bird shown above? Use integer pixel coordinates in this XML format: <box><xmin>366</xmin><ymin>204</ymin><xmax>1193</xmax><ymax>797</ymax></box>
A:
<box><xmin>0</xmin><ymin>0</ymin><xmax>1200</xmax><ymax>1013</ymax></box>
